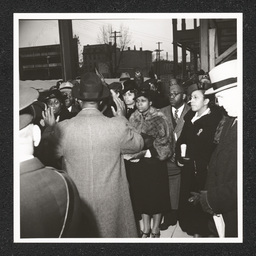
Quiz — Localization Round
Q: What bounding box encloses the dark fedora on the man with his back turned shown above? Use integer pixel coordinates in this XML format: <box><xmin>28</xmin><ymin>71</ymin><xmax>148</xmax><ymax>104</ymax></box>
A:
<box><xmin>72</xmin><ymin>72</ymin><xmax>110</xmax><ymax>101</ymax></box>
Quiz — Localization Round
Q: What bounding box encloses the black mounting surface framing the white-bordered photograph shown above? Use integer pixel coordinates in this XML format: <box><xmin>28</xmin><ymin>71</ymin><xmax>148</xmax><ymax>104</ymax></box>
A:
<box><xmin>0</xmin><ymin>0</ymin><xmax>256</xmax><ymax>256</ymax></box>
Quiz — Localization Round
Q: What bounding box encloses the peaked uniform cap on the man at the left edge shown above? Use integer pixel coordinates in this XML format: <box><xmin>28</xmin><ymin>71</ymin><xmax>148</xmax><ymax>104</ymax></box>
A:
<box><xmin>19</xmin><ymin>88</ymin><xmax>39</xmax><ymax>130</ymax></box>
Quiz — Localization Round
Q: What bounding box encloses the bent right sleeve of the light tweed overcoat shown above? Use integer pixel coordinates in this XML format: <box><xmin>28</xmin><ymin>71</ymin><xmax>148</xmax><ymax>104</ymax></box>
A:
<box><xmin>117</xmin><ymin>118</ymin><xmax>144</xmax><ymax>154</ymax></box>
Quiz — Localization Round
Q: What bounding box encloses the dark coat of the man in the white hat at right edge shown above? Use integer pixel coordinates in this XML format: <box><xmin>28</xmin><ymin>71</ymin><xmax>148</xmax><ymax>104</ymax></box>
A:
<box><xmin>206</xmin><ymin>117</ymin><xmax>237</xmax><ymax>237</ymax></box>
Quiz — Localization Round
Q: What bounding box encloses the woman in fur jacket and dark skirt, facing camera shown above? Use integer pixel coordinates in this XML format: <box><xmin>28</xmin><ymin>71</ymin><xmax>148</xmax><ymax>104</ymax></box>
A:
<box><xmin>126</xmin><ymin>91</ymin><xmax>172</xmax><ymax>238</ymax></box>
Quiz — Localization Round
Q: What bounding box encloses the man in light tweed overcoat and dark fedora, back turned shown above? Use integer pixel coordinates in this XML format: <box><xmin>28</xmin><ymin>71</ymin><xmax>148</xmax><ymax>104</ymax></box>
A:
<box><xmin>43</xmin><ymin>73</ymin><xmax>144</xmax><ymax>238</ymax></box>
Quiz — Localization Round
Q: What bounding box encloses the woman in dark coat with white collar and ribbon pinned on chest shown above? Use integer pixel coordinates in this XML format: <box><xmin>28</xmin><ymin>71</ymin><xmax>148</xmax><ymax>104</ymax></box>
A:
<box><xmin>176</xmin><ymin>84</ymin><xmax>222</xmax><ymax>236</ymax></box>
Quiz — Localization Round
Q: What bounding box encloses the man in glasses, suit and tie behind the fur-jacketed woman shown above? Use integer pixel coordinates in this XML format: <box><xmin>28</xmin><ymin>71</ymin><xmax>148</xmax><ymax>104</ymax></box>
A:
<box><xmin>160</xmin><ymin>79</ymin><xmax>190</xmax><ymax>230</ymax></box>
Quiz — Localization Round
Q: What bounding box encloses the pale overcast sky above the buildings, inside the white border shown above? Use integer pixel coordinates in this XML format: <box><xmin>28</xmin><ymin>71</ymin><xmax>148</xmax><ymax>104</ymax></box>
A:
<box><xmin>19</xmin><ymin>17</ymin><xmax>197</xmax><ymax>60</ymax></box>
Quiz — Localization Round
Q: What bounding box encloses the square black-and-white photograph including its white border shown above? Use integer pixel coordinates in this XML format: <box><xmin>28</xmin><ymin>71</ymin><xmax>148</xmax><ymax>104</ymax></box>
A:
<box><xmin>13</xmin><ymin>13</ymin><xmax>243</xmax><ymax>243</ymax></box>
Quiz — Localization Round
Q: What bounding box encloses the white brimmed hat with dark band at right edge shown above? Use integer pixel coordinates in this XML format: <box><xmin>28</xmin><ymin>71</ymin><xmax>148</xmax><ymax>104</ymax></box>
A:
<box><xmin>205</xmin><ymin>60</ymin><xmax>237</xmax><ymax>94</ymax></box>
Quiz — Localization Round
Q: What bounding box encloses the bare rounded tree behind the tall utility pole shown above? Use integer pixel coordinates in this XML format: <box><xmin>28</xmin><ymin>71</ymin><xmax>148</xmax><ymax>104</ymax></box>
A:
<box><xmin>97</xmin><ymin>24</ymin><xmax>131</xmax><ymax>76</ymax></box>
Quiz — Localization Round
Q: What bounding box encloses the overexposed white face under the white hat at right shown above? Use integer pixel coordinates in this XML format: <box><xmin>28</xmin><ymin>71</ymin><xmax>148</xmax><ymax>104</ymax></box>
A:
<box><xmin>215</xmin><ymin>87</ymin><xmax>239</xmax><ymax>117</ymax></box>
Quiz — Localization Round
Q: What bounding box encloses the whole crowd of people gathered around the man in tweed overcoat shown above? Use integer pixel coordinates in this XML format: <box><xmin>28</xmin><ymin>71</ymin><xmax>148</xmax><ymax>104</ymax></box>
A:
<box><xmin>19</xmin><ymin>60</ymin><xmax>239</xmax><ymax>238</ymax></box>
